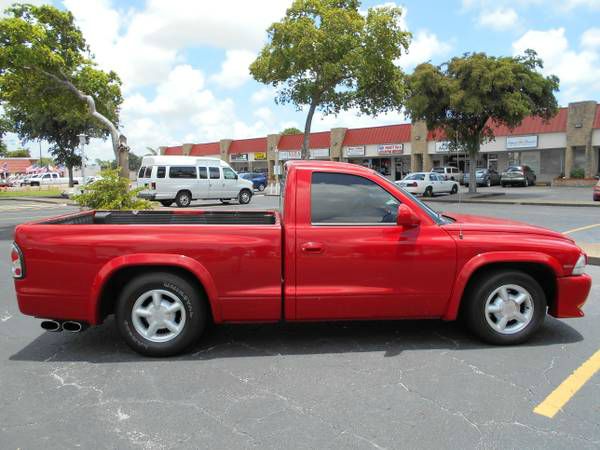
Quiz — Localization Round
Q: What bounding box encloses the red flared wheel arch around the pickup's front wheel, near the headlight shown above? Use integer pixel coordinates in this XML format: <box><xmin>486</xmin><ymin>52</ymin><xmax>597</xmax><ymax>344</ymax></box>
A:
<box><xmin>442</xmin><ymin>252</ymin><xmax>564</xmax><ymax>320</ymax></box>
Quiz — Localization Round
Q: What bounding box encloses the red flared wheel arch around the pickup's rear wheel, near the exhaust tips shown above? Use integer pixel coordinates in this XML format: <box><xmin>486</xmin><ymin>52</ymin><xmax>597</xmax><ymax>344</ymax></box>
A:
<box><xmin>88</xmin><ymin>253</ymin><xmax>221</xmax><ymax>324</ymax></box>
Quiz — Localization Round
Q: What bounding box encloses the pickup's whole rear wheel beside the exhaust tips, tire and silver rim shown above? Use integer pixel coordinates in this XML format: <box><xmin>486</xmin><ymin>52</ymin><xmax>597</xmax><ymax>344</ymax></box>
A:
<box><xmin>116</xmin><ymin>272</ymin><xmax>208</xmax><ymax>356</ymax></box>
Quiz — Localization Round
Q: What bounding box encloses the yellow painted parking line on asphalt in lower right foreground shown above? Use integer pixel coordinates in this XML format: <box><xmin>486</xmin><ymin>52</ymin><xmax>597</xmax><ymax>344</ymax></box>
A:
<box><xmin>533</xmin><ymin>350</ymin><xmax>600</xmax><ymax>418</ymax></box>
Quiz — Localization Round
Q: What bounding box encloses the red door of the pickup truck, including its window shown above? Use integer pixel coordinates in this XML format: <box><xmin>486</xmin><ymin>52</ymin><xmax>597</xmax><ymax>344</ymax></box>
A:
<box><xmin>294</xmin><ymin>171</ymin><xmax>456</xmax><ymax>320</ymax></box>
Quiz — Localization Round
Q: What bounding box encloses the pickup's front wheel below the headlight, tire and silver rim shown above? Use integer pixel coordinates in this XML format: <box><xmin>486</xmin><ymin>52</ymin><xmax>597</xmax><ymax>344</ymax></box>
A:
<box><xmin>463</xmin><ymin>271</ymin><xmax>546</xmax><ymax>345</ymax></box>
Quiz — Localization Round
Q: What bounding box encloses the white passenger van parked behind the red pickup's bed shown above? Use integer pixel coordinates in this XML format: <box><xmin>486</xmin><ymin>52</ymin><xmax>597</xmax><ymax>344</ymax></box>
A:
<box><xmin>137</xmin><ymin>156</ymin><xmax>252</xmax><ymax>207</ymax></box>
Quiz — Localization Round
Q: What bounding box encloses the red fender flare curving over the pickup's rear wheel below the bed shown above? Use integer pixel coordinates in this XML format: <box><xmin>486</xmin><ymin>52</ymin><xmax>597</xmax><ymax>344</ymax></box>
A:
<box><xmin>88</xmin><ymin>253</ymin><xmax>221</xmax><ymax>324</ymax></box>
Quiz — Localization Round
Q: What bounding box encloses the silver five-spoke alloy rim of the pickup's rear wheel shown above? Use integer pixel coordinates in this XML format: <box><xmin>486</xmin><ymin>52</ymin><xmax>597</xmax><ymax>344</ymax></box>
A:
<box><xmin>131</xmin><ymin>289</ymin><xmax>186</xmax><ymax>342</ymax></box>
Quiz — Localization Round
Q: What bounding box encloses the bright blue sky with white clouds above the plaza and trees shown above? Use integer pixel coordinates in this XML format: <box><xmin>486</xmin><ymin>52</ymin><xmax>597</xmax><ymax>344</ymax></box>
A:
<box><xmin>0</xmin><ymin>0</ymin><xmax>600</xmax><ymax>161</ymax></box>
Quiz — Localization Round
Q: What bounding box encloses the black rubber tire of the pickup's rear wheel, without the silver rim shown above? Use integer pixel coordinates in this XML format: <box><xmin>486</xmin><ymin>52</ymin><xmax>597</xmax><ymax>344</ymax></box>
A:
<box><xmin>115</xmin><ymin>272</ymin><xmax>209</xmax><ymax>357</ymax></box>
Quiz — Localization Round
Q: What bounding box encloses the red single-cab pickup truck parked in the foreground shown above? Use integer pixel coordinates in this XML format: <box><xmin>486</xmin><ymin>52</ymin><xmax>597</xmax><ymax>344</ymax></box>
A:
<box><xmin>11</xmin><ymin>161</ymin><xmax>591</xmax><ymax>356</ymax></box>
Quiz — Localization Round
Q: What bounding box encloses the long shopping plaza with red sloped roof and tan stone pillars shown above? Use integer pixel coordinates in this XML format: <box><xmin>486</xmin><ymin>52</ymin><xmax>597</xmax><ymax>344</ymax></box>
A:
<box><xmin>160</xmin><ymin>101</ymin><xmax>600</xmax><ymax>182</ymax></box>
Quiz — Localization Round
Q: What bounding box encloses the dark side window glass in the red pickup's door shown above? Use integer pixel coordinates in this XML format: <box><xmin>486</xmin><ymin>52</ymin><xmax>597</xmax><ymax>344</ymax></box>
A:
<box><xmin>311</xmin><ymin>172</ymin><xmax>400</xmax><ymax>225</ymax></box>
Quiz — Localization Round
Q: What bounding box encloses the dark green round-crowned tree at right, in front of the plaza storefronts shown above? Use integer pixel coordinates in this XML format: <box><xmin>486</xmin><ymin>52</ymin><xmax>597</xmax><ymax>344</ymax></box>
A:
<box><xmin>406</xmin><ymin>50</ymin><xmax>558</xmax><ymax>192</ymax></box>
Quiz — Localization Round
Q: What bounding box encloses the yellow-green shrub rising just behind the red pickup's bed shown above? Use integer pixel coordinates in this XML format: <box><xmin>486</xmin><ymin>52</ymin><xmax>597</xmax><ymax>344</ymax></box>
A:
<box><xmin>73</xmin><ymin>169</ymin><xmax>154</xmax><ymax>210</ymax></box>
